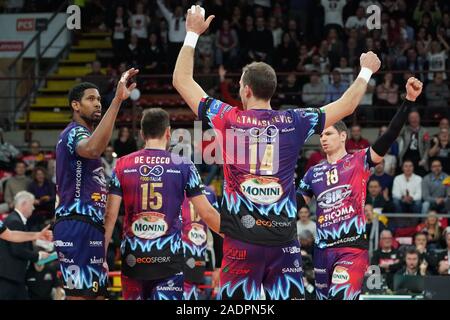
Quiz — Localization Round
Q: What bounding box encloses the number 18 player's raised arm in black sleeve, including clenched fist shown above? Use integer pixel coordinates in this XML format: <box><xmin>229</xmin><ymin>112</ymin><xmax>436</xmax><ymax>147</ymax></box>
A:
<box><xmin>370</xmin><ymin>77</ymin><xmax>423</xmax><ymax>163</ymax></box>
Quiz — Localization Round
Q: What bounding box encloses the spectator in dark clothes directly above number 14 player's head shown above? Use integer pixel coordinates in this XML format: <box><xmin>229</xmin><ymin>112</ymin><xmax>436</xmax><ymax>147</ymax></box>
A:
<box><xmin>248</xmin><ymin>17</ymin><xmax>274</xmax><ymax>64</ymax></box>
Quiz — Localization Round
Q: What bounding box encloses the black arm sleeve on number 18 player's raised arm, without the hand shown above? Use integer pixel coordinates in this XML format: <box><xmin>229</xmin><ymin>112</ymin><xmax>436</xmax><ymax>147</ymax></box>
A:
<box><xmin>372</xmin><ymin>99</ymin><xmax>414</xmax><ymax>157</ymax></box>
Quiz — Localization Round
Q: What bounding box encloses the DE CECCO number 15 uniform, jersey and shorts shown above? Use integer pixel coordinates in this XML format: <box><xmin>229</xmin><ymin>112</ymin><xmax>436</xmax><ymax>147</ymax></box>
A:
<box><xmin>109</xmin><ymin>149</ymin><xmax>203</xmax><ymax>300</ymax></box>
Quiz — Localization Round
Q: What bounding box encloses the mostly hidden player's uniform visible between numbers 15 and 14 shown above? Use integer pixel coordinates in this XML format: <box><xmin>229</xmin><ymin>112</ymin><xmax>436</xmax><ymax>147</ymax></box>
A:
<box><xmin>182</xmin><ymin>186</ymin><xmax>219</xmax><ymax>300</ymax></box>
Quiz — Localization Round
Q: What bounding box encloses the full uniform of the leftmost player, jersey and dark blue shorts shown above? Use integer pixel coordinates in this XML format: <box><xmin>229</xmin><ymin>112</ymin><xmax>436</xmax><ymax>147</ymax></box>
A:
<box><xmin>54</xmin><ymin>122</ymin><xmax>108</xmax><ymax>297</ymax></box>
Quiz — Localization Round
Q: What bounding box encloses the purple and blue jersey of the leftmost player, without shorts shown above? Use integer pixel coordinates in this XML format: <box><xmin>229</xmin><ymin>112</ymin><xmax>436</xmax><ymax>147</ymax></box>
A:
<box><xmin>55</xmin><ymin>122</ymin><xmax>108</xmax><ymax>226</ymax></box>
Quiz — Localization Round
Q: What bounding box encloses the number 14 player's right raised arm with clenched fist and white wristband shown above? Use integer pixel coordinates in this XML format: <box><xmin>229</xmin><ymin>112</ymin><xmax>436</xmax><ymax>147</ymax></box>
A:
<box><xmin>321</xmin><ymin>51</ymin><xmax>381</xmax><ymax>128</ymax></box>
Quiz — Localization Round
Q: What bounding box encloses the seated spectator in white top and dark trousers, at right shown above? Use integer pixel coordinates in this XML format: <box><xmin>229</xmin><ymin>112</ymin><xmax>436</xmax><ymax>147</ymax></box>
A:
<box><xmin>392</xmin><ymin>160</ymin><xmax>422</xmax><ymax>213</ymax></box>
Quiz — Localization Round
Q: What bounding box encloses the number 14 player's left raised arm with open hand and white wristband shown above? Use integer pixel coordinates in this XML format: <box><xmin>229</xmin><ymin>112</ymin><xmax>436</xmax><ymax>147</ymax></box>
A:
<box><xmin>172</xmin><ymin>6</ymin><xmax>214</xmax><ymax>115</ymax></box>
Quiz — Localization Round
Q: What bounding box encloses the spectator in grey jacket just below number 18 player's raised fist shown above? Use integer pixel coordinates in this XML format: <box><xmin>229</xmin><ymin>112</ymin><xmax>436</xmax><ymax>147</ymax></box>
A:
<box><xmin>398</xmin><ymin>111</ymin><xmax>430</xmax><ymax>176</ymax></box>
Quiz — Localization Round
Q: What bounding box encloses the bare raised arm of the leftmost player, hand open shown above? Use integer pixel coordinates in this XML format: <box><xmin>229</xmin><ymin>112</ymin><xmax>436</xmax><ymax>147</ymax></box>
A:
<box><xmin>76</xmin><ymin>68</ymin><xmax>139</xmax><ymax>159</ymax></box>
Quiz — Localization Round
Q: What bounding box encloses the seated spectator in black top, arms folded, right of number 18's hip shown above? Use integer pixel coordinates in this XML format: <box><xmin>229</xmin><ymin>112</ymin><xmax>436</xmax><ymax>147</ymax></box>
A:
<box><xmin>370</xmin><ymin>229</ymin><xmax>401</xmax><ymax>288</ymax></box>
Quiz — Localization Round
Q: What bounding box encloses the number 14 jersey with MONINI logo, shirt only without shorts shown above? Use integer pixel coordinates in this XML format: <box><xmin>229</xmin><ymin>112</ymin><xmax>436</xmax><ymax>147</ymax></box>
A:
<box><xmin>199</xmin><ymin>98</ymin><xmax>325</xmax><ymax>245</ymax></box>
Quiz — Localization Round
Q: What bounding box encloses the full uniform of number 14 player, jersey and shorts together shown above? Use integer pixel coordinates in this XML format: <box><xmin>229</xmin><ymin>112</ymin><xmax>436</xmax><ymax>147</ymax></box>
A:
<box><xmin>199</xmin><ymin>97</ymin><xmax>325</xmax><ymax>300</ymax></box>
